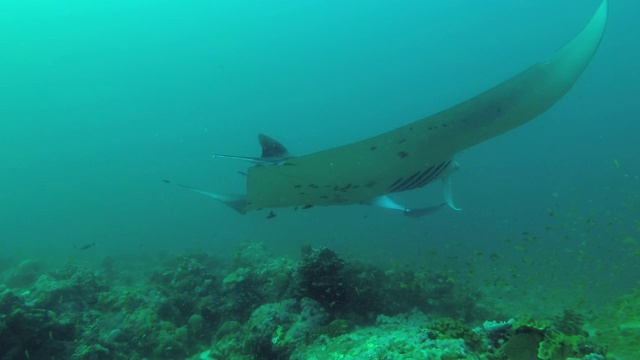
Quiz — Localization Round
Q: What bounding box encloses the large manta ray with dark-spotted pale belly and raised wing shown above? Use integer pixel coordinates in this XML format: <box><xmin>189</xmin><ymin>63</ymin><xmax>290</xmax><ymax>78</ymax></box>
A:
<box><xmin>172</xmin><ymin>0</ymin><xmax>608</xmax><ymax>218</ymax></box>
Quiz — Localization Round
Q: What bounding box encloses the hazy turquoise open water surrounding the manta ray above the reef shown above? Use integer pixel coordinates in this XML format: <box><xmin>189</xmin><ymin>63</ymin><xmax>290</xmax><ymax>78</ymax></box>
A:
<box><xmin>0</xmin><ymin>0</ymin><xmax>640</xmax><ymax>324</ymax></box>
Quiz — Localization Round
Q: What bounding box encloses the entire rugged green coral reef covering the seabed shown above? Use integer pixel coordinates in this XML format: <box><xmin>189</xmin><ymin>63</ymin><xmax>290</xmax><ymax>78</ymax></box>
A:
<box><xmin>0</xmin><ymin>243</ymin><xmax>612</xmax><ymax>360</ymax></box>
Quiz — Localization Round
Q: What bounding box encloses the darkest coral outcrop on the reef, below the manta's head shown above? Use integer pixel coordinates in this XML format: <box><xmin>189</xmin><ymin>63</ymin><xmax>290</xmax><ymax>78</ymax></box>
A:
<box><xmin>294</xmin><ymin>246</ymin><xmax>484</xmax><ymax>323</ymax></box>
